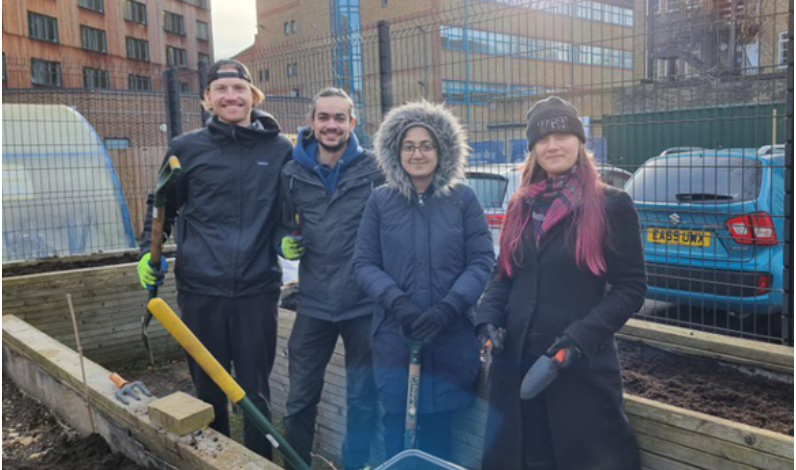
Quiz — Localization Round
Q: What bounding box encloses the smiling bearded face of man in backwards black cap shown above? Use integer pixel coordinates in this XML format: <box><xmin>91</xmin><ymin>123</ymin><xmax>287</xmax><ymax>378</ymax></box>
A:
<box><xmin>205</xmin><ymin>68</ymin><xmax>254</xmax><ymax>127</ymax></box>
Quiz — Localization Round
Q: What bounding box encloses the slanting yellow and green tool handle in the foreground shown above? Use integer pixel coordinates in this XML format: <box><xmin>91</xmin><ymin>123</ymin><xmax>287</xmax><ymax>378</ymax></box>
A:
<box><xmin>148</xmin><ymin>299</ymin><xmax>310</xmax><ymax>470</ymax></box>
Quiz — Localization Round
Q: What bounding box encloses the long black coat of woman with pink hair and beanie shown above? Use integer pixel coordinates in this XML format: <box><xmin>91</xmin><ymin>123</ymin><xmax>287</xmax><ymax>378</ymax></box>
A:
<box><xmin>477</xmin><ymin>188</ymin><xmax>646</xmax><ymax>470</ymax></box>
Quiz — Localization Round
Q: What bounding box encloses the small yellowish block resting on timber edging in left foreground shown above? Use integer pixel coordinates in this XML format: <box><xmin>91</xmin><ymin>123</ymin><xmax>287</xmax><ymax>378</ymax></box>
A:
<box><xmin>149</xmin><ymin>392</ymin><xmax>215</xmax><ymax>436</ymax></box>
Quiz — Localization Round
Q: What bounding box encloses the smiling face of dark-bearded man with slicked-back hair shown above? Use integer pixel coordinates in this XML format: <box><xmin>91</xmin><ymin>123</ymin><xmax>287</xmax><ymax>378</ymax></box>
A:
<box><xmin>311</xmin><ymin>96</ymin><xmax>357</xmax><ymax>153</ymax></box>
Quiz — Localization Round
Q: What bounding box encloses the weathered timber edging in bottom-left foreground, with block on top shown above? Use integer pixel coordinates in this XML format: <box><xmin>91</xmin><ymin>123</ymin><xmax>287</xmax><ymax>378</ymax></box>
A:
<box><xmin>3</xmin><ymin>316</ymin><xmax>281</xmax><ymax>470</ymax></box>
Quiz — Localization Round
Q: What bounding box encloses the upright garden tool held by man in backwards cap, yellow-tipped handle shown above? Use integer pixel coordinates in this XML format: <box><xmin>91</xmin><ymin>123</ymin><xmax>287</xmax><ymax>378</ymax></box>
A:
<box><xmin>141</xmin><ymin>156</ymin><xmax>182</xmax><ymax>366</ymax></box>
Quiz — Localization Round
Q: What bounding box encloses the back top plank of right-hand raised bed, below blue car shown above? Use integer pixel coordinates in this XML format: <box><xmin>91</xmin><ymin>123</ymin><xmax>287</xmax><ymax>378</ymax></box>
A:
<box><xmin>621</xmin><ymin>319</ymin><xmax>793</xmax><ymax>373</ymax></box>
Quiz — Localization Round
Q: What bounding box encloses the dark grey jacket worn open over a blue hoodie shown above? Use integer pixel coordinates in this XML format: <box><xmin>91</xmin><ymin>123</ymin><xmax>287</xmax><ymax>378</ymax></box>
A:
<box><xmin>279</xmin><ymin>150</ymin><xmax>384</xmax><ymax>321</ymax></box>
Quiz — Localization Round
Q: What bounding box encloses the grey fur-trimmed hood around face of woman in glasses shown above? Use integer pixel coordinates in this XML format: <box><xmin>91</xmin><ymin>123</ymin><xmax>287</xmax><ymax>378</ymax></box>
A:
<box><xmin>374</xmin><ymin>100</ymin><xmax>470</xmax><ymax>198</ymax></box>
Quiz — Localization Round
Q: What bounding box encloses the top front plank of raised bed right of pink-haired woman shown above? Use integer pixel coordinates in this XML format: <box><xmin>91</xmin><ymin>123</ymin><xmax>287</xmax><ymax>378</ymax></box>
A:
<box><xmin>625</xmin><ymin>394</ymin><xmax>793</xmax><ymax>461</ymax></box>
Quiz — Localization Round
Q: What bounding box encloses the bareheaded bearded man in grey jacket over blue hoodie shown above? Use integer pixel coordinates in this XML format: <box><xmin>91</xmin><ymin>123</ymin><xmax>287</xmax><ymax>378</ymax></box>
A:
<box><xmin>280</xmin><ymin>88</ymin><xmax>384</xmax><ymax>469</ymax></box>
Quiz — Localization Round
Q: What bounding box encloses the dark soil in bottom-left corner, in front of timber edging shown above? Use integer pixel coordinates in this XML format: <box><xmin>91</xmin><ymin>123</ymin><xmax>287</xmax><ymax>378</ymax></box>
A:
<box><xmin>3</xmin><ymin>378</ymin><xmax>144</xmax><ymax>470</ymax></box>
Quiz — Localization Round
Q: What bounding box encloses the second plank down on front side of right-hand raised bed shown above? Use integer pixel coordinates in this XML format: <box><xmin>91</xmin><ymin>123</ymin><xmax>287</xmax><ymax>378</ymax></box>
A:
<box><xmin>633</xmin><ymin>417</ymin><xmax>793</xmax><ymax>470</ymax></box>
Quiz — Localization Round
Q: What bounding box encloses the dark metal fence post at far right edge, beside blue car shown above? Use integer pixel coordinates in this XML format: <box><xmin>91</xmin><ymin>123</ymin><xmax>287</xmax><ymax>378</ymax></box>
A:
<box><xmin>782</xmin><ymin>0</ymin><xmax>793</xmax><ymax>346</ymax></box>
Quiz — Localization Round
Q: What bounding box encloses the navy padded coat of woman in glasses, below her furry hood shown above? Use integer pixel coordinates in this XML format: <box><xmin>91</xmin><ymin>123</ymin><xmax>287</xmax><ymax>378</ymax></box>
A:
<box><xmin>354</xmin><ymin>184</ymin><xmax>495</xmax><ymax>413</ymax></box>
